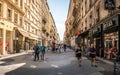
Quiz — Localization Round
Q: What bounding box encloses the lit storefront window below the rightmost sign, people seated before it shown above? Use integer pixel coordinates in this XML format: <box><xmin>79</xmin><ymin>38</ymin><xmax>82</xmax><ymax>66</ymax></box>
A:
<box><xmin>104</xmin><ymin>32</ymin><xmax>118</xmax><ymax>60</ymax></box>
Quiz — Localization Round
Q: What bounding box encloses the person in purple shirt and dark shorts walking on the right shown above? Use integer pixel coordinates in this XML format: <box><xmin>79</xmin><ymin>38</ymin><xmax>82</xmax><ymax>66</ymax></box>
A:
<box><xmin>89</xmin><ymin>44</ymin><xmax>97</xmax><ymax>67</ymax></box>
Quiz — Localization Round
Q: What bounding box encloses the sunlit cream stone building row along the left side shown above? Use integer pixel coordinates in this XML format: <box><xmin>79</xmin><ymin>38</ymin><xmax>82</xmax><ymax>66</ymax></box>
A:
<box><xmin>0</xmin><ymin>0</ymin><xmax>57</xmax><ymax>55</ymax></box>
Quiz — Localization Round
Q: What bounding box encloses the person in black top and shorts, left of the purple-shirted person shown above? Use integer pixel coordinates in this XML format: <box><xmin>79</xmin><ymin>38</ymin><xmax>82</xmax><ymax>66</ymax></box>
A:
<box><xmin>75</xmin><ymin>46</ymin><xmax>82</xmax><ymax>67</ymax></box>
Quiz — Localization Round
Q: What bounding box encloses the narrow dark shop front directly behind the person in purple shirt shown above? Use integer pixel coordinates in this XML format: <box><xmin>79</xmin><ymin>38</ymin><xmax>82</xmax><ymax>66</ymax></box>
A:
<box><xmin>91</xmin><ymin>24</ymin><xmax>104</xmax><ymax>57</ymax></box>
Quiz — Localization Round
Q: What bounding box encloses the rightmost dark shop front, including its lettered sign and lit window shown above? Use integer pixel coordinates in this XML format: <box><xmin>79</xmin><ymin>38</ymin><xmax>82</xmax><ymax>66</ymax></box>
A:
<box><xmin>102</xmin><ymin>14</ymin><xmax>120</xmax><ymax>59</ymax></box>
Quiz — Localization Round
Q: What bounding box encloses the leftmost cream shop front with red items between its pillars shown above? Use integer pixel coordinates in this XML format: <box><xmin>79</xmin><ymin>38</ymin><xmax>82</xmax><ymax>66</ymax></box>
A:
<box><xmin>0</xmin><ymin>19</ymin><xmax>14</xmax><ymax>55</ymax></box>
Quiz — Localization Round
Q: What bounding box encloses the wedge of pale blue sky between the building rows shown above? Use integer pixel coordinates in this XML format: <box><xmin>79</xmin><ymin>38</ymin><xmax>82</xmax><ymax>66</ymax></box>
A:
<box><xmin>47</xmin><ymin>0</ymin><xmax>70</xmax><ymax>41</ymax></box>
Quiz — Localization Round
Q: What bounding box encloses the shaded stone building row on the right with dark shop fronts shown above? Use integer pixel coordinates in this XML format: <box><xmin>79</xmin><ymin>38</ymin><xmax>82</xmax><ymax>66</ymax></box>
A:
<box><xmin>64</xmin><ymin>0</ymin><xmax>120</xmax><ymax>57</ymax></box>
